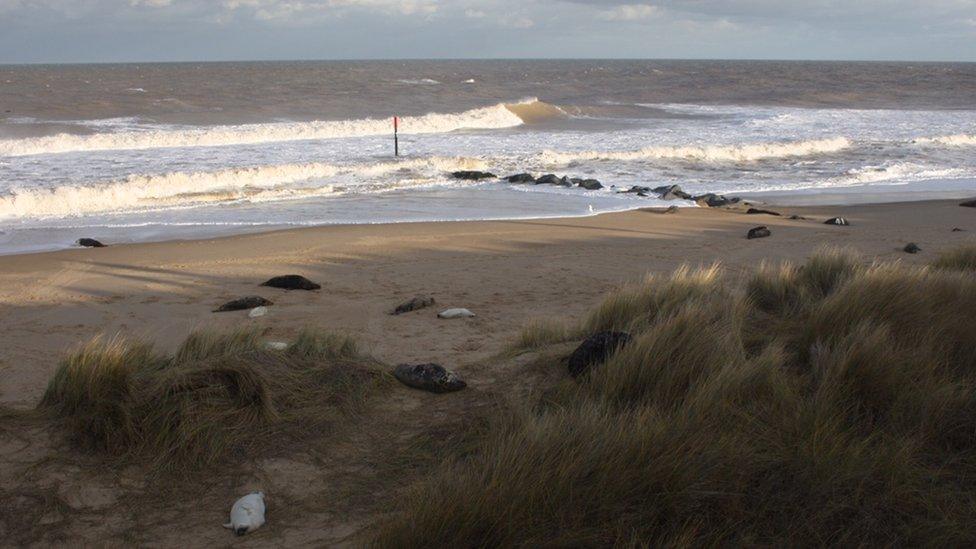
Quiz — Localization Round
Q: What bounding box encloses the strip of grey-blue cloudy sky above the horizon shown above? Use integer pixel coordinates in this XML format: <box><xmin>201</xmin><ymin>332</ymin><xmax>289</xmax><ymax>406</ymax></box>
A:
<box><xmin>0</xmin><ymin>0</ymin><xmax>976</xmax><ymax>63</ymax></box>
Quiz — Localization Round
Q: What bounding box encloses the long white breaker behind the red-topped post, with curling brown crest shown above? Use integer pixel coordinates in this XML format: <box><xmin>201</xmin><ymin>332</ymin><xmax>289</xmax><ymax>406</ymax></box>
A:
<box><xmin>0</xmin><ymin>98</ymin><xmax>561</xmax><ymax>156</ymax></box>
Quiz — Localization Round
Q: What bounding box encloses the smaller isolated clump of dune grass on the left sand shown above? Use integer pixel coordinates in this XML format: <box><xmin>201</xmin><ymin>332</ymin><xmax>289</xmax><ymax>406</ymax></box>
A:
<box><xmin>39</xmin><ymin>329</ymin><xmax>388</xmax><ymax>471</ymax></box>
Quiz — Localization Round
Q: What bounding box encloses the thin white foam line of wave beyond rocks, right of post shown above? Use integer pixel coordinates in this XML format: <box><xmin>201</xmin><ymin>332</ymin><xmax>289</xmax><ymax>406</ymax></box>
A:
<box><xmin>540</xmin><ymin>137</ymin><xmax>851</xmax><ymax>164</ymax></box>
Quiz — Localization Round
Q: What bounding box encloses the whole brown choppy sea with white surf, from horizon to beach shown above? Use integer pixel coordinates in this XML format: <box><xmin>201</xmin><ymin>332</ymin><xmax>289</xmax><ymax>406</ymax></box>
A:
<box><xmin>0</xmin><ymin>60</ymin><xmax>976</xmax><ymax>254</ymax></box>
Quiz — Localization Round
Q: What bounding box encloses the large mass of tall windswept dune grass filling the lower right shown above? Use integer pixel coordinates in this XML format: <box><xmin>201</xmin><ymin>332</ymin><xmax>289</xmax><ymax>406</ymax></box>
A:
<box><xmin>373</xmin><ymin>246</ymin><xmax>976</xmax><ymax>547</ymax></box>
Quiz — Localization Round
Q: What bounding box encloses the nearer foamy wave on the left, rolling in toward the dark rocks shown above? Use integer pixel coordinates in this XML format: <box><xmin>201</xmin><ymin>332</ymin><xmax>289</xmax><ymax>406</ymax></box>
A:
<box><xmin>0</xmin><ymin>157</ymin><xmax>485</xmax><ymax>219</ymax></box>
